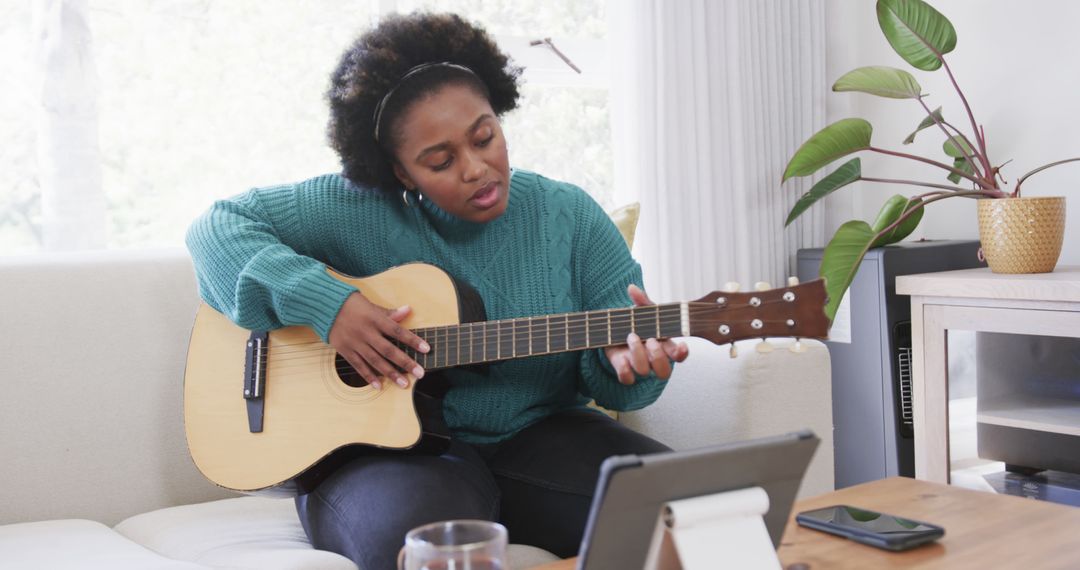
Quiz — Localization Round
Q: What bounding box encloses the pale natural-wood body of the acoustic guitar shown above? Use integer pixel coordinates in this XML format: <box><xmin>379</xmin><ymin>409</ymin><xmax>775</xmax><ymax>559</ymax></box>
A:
<box><xmin>184</xmin><ymin>263</ymin><xmax>483</xmax><ymax>496</ymax></box>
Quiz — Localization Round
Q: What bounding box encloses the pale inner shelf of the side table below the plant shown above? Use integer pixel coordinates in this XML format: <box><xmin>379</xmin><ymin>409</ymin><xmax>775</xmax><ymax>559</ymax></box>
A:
<box><xmin>976</xmin><ymin>394</ymin><xmax>1080</xmax><ymax>436</ymax></box>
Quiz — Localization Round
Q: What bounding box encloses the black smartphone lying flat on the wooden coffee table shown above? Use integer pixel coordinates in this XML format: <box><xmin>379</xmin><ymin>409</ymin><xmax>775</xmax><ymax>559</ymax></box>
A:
<box><xmin>795</xmin><ymin>505</ymin><xmax>945</xmax><ymax>551</ymax></box>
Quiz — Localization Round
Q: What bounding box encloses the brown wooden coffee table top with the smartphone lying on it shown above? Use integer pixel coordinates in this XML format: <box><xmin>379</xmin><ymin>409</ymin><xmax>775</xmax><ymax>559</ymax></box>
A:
<box><xmin>535</xmin><ymin>477</ymin><xmax>1080</xmax><ymax>570</ymax></box>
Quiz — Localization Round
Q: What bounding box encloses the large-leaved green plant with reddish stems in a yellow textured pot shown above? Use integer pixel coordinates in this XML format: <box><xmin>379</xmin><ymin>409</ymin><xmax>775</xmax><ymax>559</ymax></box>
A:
<box><xmin>783</xmin><ymin>0</ymin><xmax>1080</xmax><ymax>318</ymax></box>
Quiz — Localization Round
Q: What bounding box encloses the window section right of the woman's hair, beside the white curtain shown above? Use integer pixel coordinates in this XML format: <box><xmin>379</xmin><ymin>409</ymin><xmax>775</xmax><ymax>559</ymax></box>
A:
<box><xmin>396</xmin><ymin>0</ymin><xmax>617</xmax><ymax>205</ymax></box>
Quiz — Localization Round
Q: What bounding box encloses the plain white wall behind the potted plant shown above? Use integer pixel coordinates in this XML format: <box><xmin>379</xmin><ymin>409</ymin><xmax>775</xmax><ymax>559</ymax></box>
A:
<box><xmin>825</xmin><ymin>0</ymin><xmax>1080</xmax><ymax>264</ymax></box>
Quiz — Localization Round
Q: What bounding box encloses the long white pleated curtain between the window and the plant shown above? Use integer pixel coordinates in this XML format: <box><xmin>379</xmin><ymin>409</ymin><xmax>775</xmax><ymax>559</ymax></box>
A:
<box><xmin>608</xmin><ymin>0</ymin><xmax>827</xmax><ymax>302</ymax></box>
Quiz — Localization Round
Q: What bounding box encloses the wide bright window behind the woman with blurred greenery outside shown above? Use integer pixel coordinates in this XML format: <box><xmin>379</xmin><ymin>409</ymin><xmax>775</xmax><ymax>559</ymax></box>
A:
<box><xmin>0</xmin><ymin>0</ymin><xmax>615</xmax><ymax>254</ymax></box>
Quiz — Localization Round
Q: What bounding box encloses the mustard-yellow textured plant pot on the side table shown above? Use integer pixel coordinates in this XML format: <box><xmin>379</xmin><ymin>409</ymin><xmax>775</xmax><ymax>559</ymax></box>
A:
<box><xmin>978</xmin><ymin>196</ymin><xmax>1065</xmax><ymax>273</ymax></box>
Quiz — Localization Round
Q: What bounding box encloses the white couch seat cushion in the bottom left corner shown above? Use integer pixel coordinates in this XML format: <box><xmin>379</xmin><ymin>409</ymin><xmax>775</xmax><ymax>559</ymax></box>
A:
<box><xmin>0</xmin><ymin>519</ymin><xmax>206</xmax><ymax>570</ymax></box>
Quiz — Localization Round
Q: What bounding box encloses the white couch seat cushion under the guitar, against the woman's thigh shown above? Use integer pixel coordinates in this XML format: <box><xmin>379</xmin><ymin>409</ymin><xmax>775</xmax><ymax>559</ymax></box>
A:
<box><xmin>116</xmin><ymin>497</ymin><xmax>356</xmax><ymax>570</ymax></box>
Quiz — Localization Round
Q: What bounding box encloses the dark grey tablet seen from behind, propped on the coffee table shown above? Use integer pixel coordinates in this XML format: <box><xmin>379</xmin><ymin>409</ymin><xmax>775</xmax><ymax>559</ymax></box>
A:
<box><xmin>578</xmin><ymin>431</ymin><xmax>819</xmax><ymax>570</ymax></box>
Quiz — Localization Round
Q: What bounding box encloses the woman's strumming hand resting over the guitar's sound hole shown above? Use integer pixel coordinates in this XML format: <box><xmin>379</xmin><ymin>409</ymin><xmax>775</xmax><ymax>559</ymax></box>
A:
<box><xmin>329</xmin><ymin>291</ymin><xmax>431</xmax><ymax>390</ymax></box>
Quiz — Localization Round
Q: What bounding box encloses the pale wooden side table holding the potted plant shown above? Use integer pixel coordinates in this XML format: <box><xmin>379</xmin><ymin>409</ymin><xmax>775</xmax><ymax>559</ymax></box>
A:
<box><xmin>896</xmin><ymin>266</ymin><xmax>1080</xmax><ymax>483</ymax></box>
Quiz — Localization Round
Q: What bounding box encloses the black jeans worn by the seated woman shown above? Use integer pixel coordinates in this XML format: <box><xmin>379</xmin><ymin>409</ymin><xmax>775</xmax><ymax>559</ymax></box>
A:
<box><xmin>296</xmin><ymin>410</ymin><xmax>670</xmax><ymax>570</ymax></box>
